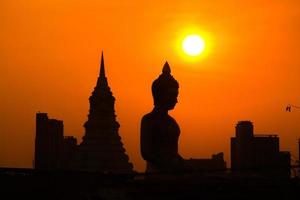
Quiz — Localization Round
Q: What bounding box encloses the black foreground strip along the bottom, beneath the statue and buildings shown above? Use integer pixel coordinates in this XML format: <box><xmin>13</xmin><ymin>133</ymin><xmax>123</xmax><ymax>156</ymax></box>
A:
<box><xmin>0</xmin><ymin>168</ymin><xmax>300</xmax><ymax>200</ymax></box>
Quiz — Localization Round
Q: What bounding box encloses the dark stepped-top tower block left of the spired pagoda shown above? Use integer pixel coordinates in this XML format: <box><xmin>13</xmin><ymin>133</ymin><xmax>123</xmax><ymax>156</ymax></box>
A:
<box><xmin>34</xmin><ymin>113</ymin><xmax>64</xmax><ymax>170</ymax></box>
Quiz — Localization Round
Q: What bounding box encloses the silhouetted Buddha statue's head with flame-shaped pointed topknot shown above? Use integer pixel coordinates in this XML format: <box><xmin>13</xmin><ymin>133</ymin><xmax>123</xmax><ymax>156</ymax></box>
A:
<box><xmin>152</xmin><ymin>62</ymin><xmax>179</xmax><ymax>110</ymax></box>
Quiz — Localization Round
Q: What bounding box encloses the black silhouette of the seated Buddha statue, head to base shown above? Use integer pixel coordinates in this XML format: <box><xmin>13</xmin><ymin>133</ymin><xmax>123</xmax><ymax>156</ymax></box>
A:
<box><xmin>140</xmin><ymin>62</ymin><xmax>185</xmax><ymax>173</ymax></box>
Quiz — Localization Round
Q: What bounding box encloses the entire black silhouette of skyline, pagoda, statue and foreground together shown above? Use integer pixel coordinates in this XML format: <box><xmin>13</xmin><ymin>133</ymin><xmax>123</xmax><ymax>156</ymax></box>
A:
<box><xmin>0</xmin><ymin>53</ymin><xmax>300</xmax><ymax>200</ymax></box>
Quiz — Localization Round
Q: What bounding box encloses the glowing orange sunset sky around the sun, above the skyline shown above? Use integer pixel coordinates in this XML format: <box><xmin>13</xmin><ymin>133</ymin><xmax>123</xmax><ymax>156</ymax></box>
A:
<box><xmin>0</xmin><ymin>0</ymin><xmax>300</xmax><ymax>171</ymax></box>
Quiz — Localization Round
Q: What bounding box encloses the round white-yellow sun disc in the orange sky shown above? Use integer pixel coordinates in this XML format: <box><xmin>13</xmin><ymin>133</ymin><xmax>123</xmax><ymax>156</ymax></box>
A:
<box><xmin>182</xmin><ymin>35</ymin><xmax>205</xmax><ymax>56</ymax></box>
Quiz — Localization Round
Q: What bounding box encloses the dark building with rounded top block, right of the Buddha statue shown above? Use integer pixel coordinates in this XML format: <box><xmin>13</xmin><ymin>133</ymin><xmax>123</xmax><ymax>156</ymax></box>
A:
<box><xmin>231</xmin><ymin>121</ymin><xmax>290</xmax><ymax>176</ymax></box>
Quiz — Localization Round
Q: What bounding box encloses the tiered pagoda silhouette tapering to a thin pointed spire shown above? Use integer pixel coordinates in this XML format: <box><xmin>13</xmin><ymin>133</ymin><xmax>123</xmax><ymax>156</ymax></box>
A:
<box><xmin>78</xmin><ymin>52</ymin><xmax>133</xmax><ymax>172</ymax></box>
